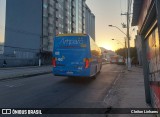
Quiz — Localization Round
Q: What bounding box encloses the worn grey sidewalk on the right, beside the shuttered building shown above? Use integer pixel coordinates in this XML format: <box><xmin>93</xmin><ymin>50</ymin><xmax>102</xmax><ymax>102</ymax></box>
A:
<box><xmin>105</xmin><ymin>67</ymin><xmax>155</xmax><ymax>117</ymax></box>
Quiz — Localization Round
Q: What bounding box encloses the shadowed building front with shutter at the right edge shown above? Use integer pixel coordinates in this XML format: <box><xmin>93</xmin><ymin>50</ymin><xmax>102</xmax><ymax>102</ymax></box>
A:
<box><xmin>132</xmin><ymin>0</ymin><xmax>160</xmax><ymax>109</ymax></box>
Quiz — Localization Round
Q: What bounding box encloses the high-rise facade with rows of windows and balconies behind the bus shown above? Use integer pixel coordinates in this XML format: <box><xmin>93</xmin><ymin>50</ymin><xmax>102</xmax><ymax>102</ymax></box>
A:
<box><xmin>42</xmin><ymin>0</ymin><xmax>85</xmax><ymax>52</ymax></box>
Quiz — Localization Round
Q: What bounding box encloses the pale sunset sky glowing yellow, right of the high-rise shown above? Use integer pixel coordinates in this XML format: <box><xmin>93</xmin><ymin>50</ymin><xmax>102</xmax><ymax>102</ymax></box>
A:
<box><xmin>86</xmin><ymin>0</ymin><xmax>136</xmax><ymax>51</ymax></box>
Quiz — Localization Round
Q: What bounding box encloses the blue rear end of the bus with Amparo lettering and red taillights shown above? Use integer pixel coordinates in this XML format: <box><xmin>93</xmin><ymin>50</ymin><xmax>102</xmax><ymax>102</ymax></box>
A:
<box><xmin>52</xmin><ymin>35</ymin><xmax>91</xmax><ymax>77</ymax></box>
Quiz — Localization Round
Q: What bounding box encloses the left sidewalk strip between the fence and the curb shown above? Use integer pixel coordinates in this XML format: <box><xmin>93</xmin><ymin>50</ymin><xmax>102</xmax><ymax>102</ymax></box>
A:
<box><xmin>0</xmin><ymin>66</ymin><xmax>52</xmax><ymax>80</ymax></box>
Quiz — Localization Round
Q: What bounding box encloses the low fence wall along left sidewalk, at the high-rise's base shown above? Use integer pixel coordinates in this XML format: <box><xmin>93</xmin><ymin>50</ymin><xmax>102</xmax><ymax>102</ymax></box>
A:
<box><xmin>0</xmin><ymin>46</ymin><xmax>52</xmax><ymax>67</ymax></box>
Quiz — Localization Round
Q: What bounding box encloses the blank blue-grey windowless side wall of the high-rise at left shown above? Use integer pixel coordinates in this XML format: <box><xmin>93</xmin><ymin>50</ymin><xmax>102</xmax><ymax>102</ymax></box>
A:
<box><xmin>4</xmin><ymin>0</ymin><xmax>42</xmax><ymax>55</ymax></box>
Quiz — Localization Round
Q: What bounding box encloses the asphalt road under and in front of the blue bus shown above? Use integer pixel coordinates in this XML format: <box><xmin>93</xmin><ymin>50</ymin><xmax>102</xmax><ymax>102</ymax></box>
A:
<box><xmin>0</xmin><ymin>64</ymin><xmax>124</xmax><ymax>116</ymax></box>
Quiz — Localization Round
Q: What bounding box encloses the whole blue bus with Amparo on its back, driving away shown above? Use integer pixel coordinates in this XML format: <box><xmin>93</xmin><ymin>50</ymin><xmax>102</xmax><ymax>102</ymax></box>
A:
<box><xmin>52</xmin><ymin>34</ymin><xmax>102</xmax><ymax>78</ymax></box>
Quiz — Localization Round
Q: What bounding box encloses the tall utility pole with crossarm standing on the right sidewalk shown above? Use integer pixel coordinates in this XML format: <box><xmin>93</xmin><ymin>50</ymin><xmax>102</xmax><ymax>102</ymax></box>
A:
<box><xmin>121</xmin><ymin>0</ymin><xmax>131</xmax><ymax>71</ymax></box>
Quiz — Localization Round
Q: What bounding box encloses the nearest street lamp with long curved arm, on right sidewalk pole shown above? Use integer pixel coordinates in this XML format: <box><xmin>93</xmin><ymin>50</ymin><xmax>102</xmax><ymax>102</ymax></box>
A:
<box><xmin>108</xmin><ymin>25</ymin><xmax>131</xmax><ymax>70</ymax></box>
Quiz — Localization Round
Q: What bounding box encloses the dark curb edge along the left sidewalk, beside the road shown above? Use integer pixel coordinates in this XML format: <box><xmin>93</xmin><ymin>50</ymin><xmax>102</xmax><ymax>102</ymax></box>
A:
<box><xmin>0</xmin><ymin>71</ymin><xmax>52</xmax><ymax>81</ymax></box>
